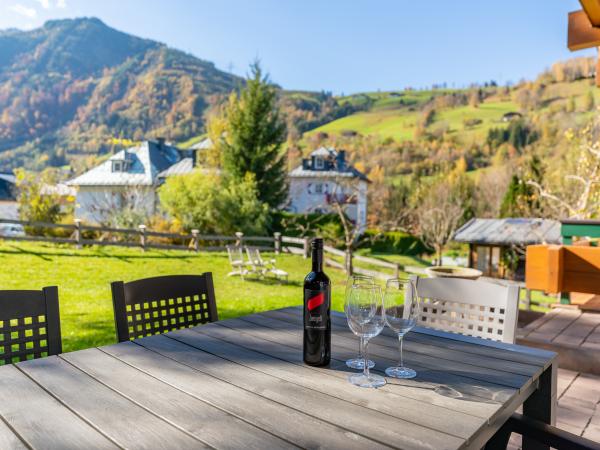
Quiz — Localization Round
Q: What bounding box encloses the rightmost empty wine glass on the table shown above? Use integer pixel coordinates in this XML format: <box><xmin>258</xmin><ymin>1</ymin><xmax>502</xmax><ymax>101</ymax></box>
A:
<box><xmin>383</xmin><ymin>278</ymin><xmax>420</xmax><ymax>378</ymax></box>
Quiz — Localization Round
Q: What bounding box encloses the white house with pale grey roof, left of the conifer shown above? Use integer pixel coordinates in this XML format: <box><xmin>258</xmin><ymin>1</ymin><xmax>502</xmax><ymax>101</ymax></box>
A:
<box><xmin>67</xmin><ymin>139</ymin><xmax>195</xmax><ymax>223</ymax></box>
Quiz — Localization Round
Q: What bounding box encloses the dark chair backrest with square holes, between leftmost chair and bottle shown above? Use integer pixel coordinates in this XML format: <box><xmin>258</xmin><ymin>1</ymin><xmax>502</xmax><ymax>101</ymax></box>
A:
<box><xmin>111</xmin><ymin>272</ymin><xmax>219</xmax><ymax>342</ymax></box>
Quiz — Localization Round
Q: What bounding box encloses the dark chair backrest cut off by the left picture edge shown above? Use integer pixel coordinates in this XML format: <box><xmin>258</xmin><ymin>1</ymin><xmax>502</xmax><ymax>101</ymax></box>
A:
<box><xmin>0</xmin><ymin>286</ymin><xmax>62</xmax><ymax>364</ymax></box>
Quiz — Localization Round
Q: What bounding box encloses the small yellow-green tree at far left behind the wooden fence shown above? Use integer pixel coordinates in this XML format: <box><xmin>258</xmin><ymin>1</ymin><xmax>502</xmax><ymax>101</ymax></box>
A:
<box><xmin>15</xmin><ymin>169</ymin><xmax>65</xmax><ymax>235</ymax></box>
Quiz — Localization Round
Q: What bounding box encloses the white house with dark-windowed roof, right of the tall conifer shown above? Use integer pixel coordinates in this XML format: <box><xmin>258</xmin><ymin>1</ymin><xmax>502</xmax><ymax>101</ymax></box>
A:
<box><xmin>288</xmin><ymin>147</ymin><xmax>370</xmax><ymax>233</ymax></box>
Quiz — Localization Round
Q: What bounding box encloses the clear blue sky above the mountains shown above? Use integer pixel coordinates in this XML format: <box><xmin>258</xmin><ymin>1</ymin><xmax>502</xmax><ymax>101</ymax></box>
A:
<box><xmin>0</xmin><ymin>0</ymin><xmax>596</xmax><ymax>94</ymax></box>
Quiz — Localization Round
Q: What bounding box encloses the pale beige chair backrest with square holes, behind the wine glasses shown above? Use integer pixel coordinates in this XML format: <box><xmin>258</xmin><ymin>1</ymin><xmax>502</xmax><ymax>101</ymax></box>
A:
<box><xmin>405</xmin><ymin>275</ymin><xmax>519</xmax><ymax>343</ymax></box>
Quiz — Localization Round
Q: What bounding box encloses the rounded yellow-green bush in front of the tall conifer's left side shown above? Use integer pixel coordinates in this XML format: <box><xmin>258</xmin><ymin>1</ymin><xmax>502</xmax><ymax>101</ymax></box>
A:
<box><xmin>159</xmin><ymin>170</ymin><xmax>268</xmax><ymax>235</ymax></box>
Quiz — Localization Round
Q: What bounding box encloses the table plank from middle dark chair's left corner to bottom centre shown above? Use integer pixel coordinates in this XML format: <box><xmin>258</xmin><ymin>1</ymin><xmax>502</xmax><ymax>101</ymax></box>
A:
<box><xmin>101</xmin><ymin>336</ymin><xmax>384</xmax><ymax>449</ymax></box>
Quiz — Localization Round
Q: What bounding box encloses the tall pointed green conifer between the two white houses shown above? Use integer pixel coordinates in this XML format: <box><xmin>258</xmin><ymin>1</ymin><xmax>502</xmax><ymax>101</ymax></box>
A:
<box><xmin>214</xmin><ymin>62</ymin><xmax>287</xmax><ymax>208</ymax></box>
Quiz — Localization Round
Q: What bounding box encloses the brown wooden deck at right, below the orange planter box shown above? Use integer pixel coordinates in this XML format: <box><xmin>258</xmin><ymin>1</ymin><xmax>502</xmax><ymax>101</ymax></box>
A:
<box><xmin>517</xmin><ymin>308</ymin><xmax>600</xmax><ymax>375</ymax></box>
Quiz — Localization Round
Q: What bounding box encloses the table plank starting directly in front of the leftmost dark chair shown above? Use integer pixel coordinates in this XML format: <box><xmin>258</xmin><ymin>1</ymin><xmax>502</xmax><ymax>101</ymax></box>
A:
<box><xmin>18</xmin><ymin>356</ymin><xmax>207</xmax><ymax>449</ymax></box>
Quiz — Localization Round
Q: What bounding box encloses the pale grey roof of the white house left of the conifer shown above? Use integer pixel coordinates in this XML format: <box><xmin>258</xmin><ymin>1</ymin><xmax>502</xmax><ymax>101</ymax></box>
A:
<box><xmin>67</xmin><ymin>141</ymin><xmax>182</xmax><ymax>186</ymax></box>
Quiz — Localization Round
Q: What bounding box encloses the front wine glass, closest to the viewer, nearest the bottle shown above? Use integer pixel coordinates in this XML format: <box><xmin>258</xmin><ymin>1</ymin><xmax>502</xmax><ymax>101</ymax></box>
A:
<box><xmin>346</xmin><ymin>284</ymin><xmax>385</xmax><ymax>388</ymax></box>
